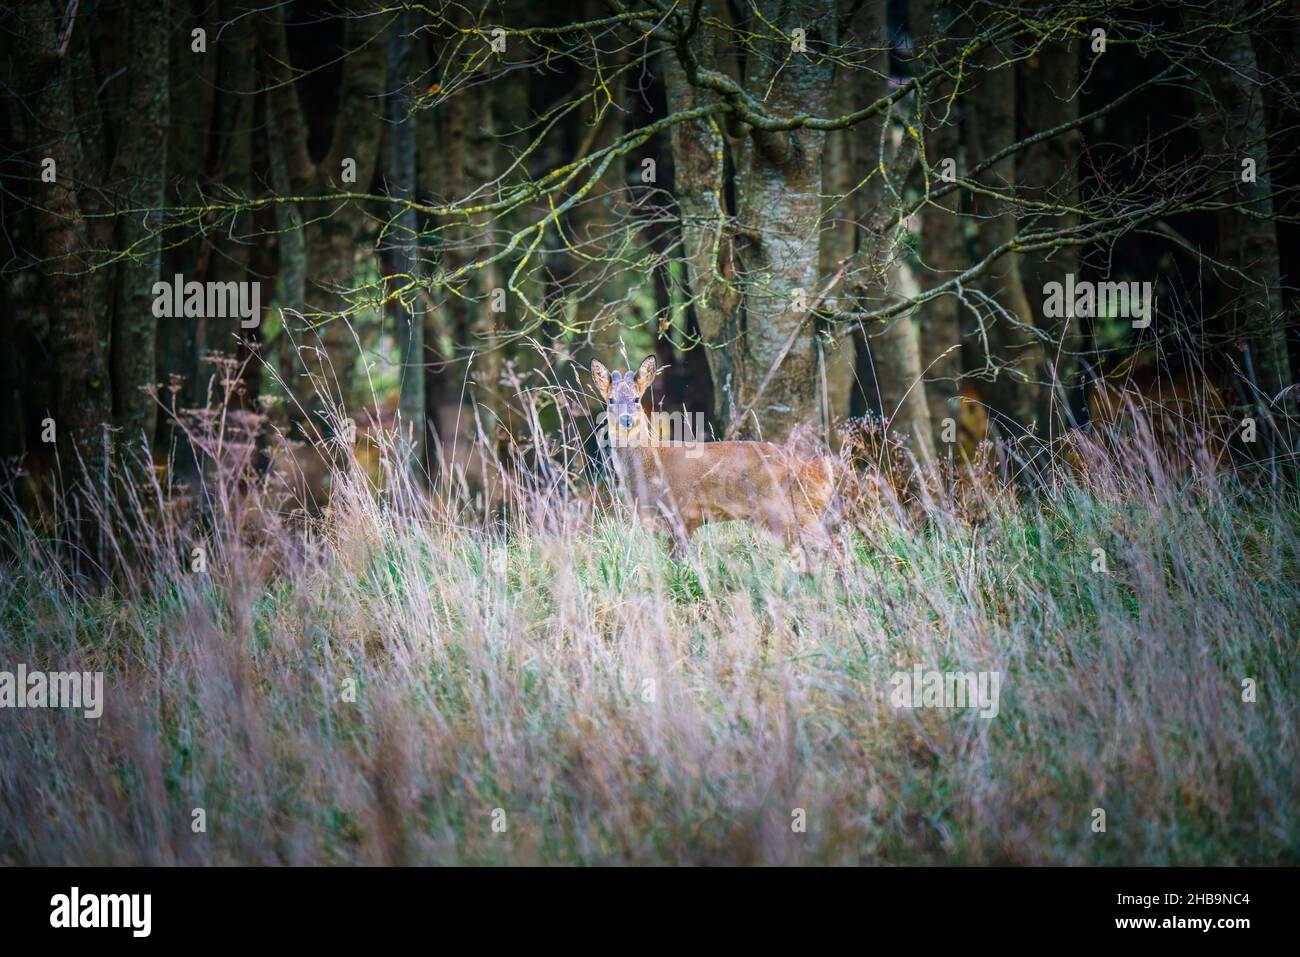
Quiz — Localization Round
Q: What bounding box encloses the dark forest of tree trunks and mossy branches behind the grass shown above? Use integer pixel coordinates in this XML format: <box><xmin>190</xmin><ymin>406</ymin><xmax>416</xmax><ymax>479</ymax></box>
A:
<box><xmin>0</xmin><ymin>0</ymin><xmax>1300</xmax><ymax>509</ymax></box>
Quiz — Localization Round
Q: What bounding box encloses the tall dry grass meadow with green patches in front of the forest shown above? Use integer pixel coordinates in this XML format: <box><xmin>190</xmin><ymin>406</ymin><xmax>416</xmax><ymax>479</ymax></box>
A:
<box><xmin>0</xmin><ymin>384</ymin><xmax>1300</xmax><ymax>865</ymax></box>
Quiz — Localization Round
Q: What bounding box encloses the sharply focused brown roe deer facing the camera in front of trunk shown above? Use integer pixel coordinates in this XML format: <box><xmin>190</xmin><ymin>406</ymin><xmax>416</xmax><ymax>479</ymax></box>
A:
<box><xmin>592</xmin><ymin>356</ymin><xmax>835</xmax><ymax>570</ymax></box>
